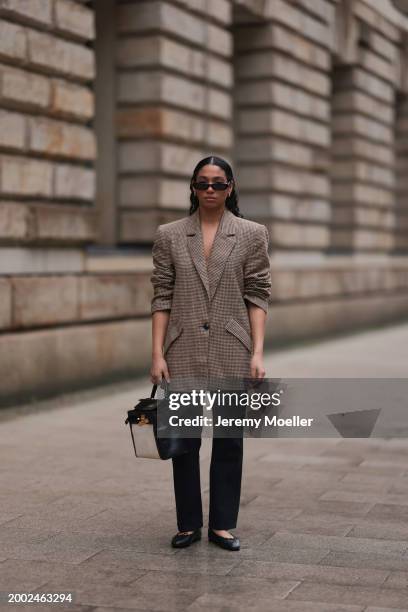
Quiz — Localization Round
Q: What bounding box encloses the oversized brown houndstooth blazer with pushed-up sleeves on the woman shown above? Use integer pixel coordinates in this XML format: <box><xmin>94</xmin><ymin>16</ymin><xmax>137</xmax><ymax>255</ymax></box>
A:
<box><xmin>151</xmin><ymin>208</ymin><xmax>271</xmax><ymax>384</ymax></box>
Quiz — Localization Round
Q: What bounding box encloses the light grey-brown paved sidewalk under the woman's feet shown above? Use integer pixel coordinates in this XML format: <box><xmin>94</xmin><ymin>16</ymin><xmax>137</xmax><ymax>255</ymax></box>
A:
<box><xmin>0</xmin><ymin>325</ymin><xmax>408</xmax><ymax>612</ymax></box>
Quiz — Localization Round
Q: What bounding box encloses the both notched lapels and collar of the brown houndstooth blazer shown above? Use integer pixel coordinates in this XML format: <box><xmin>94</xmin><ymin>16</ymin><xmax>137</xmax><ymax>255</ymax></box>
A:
<box><xmin>186</xmin><ymin>208</ymin><xmax>236</xmax><ymax>300</ymax></box>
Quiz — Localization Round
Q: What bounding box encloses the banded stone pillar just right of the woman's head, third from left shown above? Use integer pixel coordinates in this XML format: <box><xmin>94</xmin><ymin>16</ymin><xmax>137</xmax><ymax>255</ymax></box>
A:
<box><xmin>234</xmin><ymin>0</ymin><xmax>334</xmax><ymax>252</ymax></box>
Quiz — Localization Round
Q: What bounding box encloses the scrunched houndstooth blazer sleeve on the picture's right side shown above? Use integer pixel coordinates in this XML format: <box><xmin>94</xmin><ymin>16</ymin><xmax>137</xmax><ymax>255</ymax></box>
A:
<box><xmin>244</xmin><ymin>225</ymin><xmax>271</xmax><ymax>313</ymax></box>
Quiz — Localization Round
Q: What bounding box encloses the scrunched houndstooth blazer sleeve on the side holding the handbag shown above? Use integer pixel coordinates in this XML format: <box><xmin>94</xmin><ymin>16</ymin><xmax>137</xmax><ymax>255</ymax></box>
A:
<box><xmin>150</xmin><ymin>225</ymin><xmax>175</xmax><ymax>314</ymax></box>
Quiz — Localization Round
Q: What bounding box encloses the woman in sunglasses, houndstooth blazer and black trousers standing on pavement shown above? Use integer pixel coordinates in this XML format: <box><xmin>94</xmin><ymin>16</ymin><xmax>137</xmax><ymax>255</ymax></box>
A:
<box><xmin>150</xmin><ymin>156</ymin><xmax>271</xmax><ymax>550</ymax></box>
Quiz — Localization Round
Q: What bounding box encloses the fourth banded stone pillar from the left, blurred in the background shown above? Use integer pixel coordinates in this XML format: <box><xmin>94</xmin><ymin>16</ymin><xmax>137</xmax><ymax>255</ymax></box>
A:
<box><xmin>330</xmin><ymin>1</ymin><xmax>400</xmax><ymax>253</ymax></box>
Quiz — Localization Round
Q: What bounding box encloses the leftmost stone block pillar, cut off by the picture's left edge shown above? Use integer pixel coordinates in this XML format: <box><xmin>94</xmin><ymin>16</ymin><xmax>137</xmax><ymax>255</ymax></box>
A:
<box><xmin>0</xmin><ymin>0</ymin><xmax>96</xmax><ymax>251</ymax></box>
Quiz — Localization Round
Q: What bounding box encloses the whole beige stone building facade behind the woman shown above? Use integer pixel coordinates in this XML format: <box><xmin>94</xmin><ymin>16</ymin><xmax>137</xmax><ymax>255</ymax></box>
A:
<box><xmin>0</xmin><ymin>0</ymin><xmax>408</xmax><ymax>404</ymax></box>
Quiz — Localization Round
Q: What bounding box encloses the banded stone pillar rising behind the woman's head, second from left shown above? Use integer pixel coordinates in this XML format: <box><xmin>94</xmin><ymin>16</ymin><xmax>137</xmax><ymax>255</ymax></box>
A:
<box><xmin>116</xmin><ymin>0</ymin><xmax>232</xmax><ymax>243</ymax></box>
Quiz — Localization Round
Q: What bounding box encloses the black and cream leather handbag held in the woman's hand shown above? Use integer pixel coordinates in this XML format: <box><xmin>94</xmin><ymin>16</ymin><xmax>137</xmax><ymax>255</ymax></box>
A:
<box><xmin>125</xmin><ymin>384</ymin><xmax>194</xmax><ymax>459</ymax></box>
